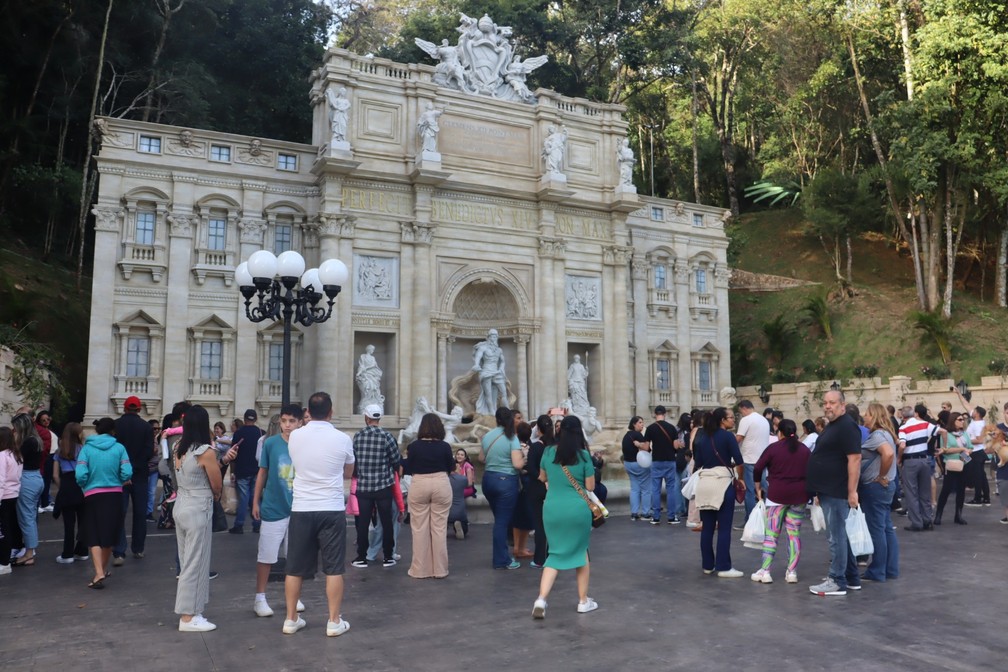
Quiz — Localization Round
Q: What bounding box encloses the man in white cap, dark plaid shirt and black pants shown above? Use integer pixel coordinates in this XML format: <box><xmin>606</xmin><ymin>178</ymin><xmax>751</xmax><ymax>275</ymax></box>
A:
<box><xmin>350</xmin><ymin>404</ymin><xmax>402</xmax><ymax>567</ymax></box>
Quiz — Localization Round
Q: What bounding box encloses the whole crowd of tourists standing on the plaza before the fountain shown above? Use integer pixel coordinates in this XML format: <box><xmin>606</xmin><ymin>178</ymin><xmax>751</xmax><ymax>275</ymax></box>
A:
<box><xmin>0</xmin><ymin>390</ymin><xmax>1008</xmax><ymax>637</ymax></box>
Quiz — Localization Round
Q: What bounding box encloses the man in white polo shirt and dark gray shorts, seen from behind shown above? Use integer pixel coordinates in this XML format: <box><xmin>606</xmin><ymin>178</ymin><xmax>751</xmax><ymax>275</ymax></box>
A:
<box><xmin>283</xmin><ymin>392</ymin><xmax>354</xmax><ymax>637</ymax></box>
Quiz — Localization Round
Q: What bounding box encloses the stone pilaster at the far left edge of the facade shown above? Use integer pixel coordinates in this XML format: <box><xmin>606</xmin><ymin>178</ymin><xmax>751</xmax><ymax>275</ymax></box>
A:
<box><xmin>85</xmin><ymin>205</ymin><xmax>126</xmax><ymax>423</ymax></box>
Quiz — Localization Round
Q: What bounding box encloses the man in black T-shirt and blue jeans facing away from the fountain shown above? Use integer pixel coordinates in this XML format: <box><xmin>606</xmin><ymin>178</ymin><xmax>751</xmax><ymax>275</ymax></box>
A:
<box><xmin>805</xmin><ymin>390</ymin><xmax>861</xmax><ymax>596</ymax></box>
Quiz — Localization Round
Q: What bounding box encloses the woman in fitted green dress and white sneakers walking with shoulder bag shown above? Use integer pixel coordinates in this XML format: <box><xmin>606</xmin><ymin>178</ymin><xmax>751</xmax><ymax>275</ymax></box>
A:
<box><xmin>532</xmin><ymin>415</ymin><xmax>599</xmax><ymax>619</ymax></box>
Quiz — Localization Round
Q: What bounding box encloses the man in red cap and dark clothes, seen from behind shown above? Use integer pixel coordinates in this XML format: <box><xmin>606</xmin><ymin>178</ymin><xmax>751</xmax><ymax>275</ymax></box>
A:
<box><xmin>112</xmin><ymin>397</ymin><xmax>154</xmax><ymax>566</ymax></box>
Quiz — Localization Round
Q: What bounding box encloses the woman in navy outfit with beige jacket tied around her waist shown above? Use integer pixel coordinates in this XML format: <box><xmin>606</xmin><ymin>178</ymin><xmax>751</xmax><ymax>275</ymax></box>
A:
<box><xmin>694</xmin><ymin>406</ymin><xmax>744</xmax><ymax>578</ymax></box>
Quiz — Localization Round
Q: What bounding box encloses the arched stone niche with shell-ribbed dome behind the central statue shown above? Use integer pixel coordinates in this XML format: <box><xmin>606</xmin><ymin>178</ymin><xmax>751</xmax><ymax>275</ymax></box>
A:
<box><xmin>447</xmin><ymin>272</ymin><xmax>528</xmax><ymax>415</ymax></box>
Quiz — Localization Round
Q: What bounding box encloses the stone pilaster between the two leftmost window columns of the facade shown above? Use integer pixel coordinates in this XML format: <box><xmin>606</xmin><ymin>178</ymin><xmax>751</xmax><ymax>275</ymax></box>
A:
<box><xmin>162</xmin><ymin>213</ymin><xmax>194</xmax><ymax>405</ymax></box>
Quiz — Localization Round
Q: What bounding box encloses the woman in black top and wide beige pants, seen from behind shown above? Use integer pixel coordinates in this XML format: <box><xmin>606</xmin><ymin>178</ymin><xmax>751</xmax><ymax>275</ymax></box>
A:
<box><xmin>405</xmin><ymin>413</ymin><xmax>455</xmax><ymax>578</ymax></box>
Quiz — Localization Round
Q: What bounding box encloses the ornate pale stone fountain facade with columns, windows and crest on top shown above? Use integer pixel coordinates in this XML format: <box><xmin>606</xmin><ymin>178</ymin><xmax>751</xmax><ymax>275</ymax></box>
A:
<box><xmin>87</xmin><ymin>26</ymin><xmax>730</xmax><ymax>428</ymax></box>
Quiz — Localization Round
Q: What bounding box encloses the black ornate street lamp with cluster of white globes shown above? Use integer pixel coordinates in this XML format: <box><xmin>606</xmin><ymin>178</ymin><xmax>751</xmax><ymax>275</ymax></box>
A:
<box><xmin>235</xmin><ymin>250</ymin><xmax>350</xmax><ymax>405</ymax></box>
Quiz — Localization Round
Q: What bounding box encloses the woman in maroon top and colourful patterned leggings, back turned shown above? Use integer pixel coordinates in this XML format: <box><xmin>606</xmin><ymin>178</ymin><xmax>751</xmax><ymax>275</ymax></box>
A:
<box><xmin>750</xmin><ymin>420</ymin><xmax>812</xmax><ymax>583</ymax></box>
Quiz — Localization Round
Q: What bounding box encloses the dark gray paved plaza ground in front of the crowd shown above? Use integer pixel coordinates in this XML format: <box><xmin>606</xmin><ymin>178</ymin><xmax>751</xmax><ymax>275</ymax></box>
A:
<box><xmin>0</xmin><ymin>503</ymin><xmax>1008</xmax><ymax>672</ymax></box>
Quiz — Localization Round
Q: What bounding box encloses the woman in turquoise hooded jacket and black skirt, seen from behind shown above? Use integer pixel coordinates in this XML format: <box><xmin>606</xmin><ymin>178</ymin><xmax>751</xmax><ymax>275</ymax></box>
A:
<box><xmin>75</xmin><ymin>418</ymin><xmax>133</xmax><ymax>589</ymax></box>
